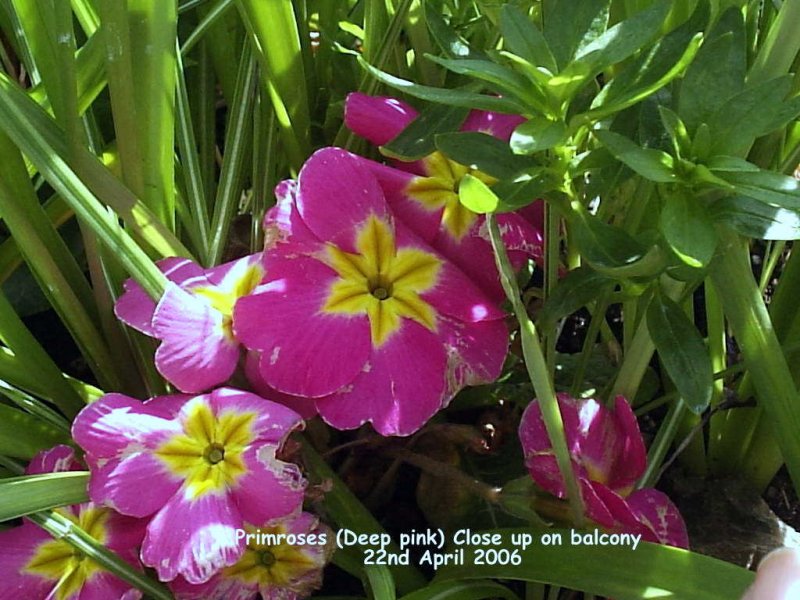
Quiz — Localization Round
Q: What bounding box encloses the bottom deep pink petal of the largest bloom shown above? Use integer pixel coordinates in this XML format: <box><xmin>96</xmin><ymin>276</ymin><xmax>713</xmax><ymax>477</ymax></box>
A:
<box><xmin>317</xmin><ymin>319</ymin><xmax>447</xmax><ymax>435</ymax></box>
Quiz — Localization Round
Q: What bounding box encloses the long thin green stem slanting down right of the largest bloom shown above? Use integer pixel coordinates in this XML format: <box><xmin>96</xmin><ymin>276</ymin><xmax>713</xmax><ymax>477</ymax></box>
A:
<box><xmin>486</xmin><ymin>214</ymin><xmax>585</xmax><ymax>527</ymax></box>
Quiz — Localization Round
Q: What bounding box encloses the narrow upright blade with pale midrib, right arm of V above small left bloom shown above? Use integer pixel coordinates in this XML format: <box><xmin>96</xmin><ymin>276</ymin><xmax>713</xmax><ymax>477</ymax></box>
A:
<box><xmin>208</xmin><ymin>43</ymin><xmax>257</xmax><ymax>265</ymax></box>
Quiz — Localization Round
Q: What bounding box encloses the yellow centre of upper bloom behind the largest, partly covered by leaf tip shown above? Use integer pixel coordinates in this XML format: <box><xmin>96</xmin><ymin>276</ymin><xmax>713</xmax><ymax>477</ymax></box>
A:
<box><xmin>406</xmin><ymin>151</ymin><xmax>497</xmax><ymax>241</ymax></box>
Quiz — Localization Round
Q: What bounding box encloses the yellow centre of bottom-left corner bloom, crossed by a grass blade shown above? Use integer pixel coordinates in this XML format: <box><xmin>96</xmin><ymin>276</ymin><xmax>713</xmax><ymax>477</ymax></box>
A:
<box><xmin>23</xmin><ymin>508</ymin><xmax>109</xmax><ymax>600</ymax></box>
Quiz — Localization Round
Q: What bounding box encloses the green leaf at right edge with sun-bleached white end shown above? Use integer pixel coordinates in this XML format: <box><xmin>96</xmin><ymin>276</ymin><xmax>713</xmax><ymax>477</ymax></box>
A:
<box><xmin>711</xmin><ymin>196</ymin><xmax>800</xmax><ymax>240</ymax></box>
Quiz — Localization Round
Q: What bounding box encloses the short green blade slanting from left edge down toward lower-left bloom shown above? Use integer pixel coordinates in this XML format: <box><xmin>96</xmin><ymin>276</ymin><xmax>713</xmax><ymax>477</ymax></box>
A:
<box><xmin>0</xmin><ymin>292</ymin><xmax>84</xmax><ymax>416</ymax></box>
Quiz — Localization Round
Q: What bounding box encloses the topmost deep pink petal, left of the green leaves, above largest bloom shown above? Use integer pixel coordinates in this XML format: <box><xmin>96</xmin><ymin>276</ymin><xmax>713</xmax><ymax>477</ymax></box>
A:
<box><xmin>344</xmin><ymin>92</ymin><xmax>417</xmax><ymax>146</ymax></box>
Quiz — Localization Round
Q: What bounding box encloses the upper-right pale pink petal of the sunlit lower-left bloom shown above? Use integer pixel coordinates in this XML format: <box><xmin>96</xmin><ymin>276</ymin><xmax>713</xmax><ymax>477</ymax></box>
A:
<box><xmin>209</xmin><ymin>388</ymin><xmax>303</xmax><ymax>444</ymax></box>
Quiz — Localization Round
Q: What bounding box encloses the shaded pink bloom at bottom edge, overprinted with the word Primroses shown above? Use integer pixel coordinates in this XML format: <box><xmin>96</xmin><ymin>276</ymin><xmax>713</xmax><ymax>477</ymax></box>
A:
<box><xmin>170</xmin><ymin>513</ymin><xmax>334</xmax><ymax>600</ymax></box>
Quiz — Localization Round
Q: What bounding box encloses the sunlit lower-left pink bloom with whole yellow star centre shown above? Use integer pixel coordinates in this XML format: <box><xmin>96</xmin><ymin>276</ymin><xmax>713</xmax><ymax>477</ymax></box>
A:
<box><xmin>72</xmin><ymin>388</ymin><xmax>305</xmax><ymax>583</ymax></box>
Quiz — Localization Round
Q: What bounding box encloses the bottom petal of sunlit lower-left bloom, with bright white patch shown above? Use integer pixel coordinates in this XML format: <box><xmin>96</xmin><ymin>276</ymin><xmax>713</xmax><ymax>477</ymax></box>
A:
<box><xmin>141</xmin><ymin>493</ymin><xmax>242</xmax><ymax>583</ymax></box>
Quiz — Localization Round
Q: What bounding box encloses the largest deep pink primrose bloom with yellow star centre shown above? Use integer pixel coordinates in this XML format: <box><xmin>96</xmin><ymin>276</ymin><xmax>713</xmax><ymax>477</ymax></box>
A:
<box><xmin>233</xmin><ymin>148</ymin><xmax>508</xmax><ymax>435</ymax></box>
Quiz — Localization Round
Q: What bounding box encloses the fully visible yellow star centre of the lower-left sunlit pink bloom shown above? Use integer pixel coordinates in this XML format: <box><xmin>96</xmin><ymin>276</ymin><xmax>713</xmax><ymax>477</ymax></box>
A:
<box><xmin>155</xmin><ymin>399</ymin><xmax>256</xmax><ymax>500</ymax></box>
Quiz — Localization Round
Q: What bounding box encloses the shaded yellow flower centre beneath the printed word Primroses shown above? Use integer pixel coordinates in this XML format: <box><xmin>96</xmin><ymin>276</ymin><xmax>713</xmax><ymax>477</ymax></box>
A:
<box><xmin>222</xmin><ymin>525</ymin><xmax>319</xmax><ymax>587</ymax></box>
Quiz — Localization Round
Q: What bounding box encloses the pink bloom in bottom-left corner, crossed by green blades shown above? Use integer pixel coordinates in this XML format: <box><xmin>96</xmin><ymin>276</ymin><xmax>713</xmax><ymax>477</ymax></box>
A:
<box><xmin>0</xmin><ymin>446</ymin><xmax>144</xmax><ymax>600</ymax></box>
